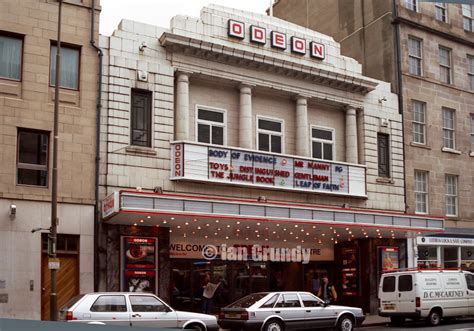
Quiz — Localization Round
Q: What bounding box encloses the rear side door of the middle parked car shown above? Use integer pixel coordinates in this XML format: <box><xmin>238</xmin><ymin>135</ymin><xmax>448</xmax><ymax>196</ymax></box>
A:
<box><xmin>274</xmin><ymin>293</ymin><xmax>305</xmax><ymax>330</ymax></box>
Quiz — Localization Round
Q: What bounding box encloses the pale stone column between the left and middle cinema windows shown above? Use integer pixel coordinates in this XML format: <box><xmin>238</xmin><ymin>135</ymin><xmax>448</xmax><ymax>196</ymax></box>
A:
<box><xmin>239</xmin><ymin>84</ymin><xmax>254</xmax><ymax>149</ymax></box>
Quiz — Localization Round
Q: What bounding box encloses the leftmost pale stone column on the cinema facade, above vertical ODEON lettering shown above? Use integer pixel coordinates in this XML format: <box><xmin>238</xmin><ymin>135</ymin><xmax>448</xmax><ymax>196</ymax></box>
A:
<box><xmin>175</xmin><ymin>71</ymin><xmax>189</xmax><ymax>140</ymax></box>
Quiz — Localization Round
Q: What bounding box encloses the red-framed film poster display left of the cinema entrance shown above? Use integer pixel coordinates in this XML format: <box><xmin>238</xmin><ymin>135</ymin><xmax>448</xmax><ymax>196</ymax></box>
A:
<box><xmin>121</xmin><ymin>237</ymin><xmax>158</xmax><ymax>293</ymax></box>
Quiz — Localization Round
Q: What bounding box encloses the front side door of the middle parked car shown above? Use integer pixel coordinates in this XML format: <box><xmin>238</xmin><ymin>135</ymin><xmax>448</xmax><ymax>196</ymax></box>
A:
<box><xmin>299</xmin><ymin>293</ymin><xmax>337</xmax><ymax>330</ymax></box>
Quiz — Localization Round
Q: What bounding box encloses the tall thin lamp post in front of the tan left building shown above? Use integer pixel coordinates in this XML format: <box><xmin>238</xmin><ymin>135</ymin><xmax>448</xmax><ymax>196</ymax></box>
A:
<box><xmin>48</xmin><ymin>0</ymin><xmax>63</xmax><ymax>321</ymax></box>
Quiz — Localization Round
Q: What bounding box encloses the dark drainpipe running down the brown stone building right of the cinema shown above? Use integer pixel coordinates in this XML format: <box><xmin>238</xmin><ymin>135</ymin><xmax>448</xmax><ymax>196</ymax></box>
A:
<box><xmin>392</xmin><ymin>0</ymin><xmax>408</xmax><ymax>213</ymax></box>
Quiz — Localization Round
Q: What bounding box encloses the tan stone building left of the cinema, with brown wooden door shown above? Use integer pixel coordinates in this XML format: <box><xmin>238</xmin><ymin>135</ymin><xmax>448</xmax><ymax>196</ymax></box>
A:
<box><xmin>0</xmin><ymin>0</ymin><xmax>99</xmax><ymax>319</ymax></box>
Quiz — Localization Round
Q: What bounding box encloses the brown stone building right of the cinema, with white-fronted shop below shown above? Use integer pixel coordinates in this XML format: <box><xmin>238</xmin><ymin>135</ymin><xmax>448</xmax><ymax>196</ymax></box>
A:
<box><xmin>273</xmin><ymin>0</ymin><xmax>474</xmax><ymax>270</ymax></box>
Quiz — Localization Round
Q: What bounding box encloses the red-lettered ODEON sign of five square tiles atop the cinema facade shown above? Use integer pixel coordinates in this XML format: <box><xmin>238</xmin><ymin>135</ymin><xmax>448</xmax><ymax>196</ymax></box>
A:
<box><xmin>227</xmin><ymin>20</ymin><xmax>326</xmax><ymax>60</ymax></box>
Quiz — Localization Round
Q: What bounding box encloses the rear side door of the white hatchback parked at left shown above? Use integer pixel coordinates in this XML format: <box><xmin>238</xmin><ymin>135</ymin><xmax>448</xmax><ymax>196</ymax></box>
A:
<box><xmin>87</xmin><ymin>295</ymin><xmax>130</xmax><ymax>326</ymax></box>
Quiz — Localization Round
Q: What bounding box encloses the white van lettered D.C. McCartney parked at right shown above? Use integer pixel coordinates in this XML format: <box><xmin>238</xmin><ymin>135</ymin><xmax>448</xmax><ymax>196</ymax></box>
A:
<box><xmin>379</xmin><ymin>270</ymin><xmax>474</xmax><ymax>325</ymax></box>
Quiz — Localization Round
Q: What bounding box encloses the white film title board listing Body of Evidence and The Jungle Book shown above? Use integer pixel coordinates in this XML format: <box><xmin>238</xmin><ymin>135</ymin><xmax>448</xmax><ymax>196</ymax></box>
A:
<box><xmin>171</xmin><ymin>143</ymin><xmax>366</xmax><ymax>197</ymax></box>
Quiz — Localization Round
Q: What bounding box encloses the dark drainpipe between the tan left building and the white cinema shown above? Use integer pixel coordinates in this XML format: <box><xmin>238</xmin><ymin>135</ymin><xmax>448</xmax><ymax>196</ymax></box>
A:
<box><xmin>90</xmin><ymin>0</ymin><xmax>104</xmax><ymax>292</ymax></box>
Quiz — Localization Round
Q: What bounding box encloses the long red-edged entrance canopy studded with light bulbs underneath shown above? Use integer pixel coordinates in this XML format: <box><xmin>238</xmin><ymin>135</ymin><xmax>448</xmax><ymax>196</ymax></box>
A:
<box><xmin>102</xmin><ymin>190</ymin><xmax>444</xmax><ymax>243</ymax></box>
